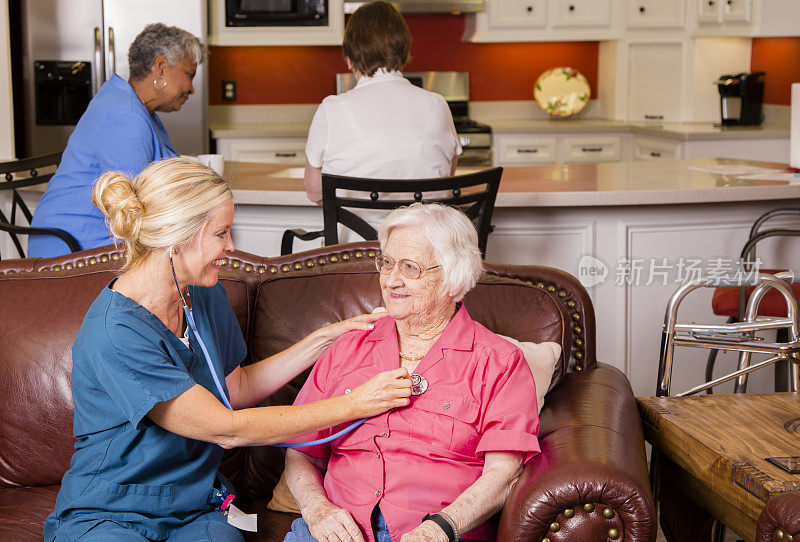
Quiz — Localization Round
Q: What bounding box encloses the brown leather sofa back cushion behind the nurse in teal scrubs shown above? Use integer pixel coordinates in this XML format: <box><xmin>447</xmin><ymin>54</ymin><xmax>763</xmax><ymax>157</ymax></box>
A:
<box><xmin>0</xmin><ymin>269</ymin><xmax>251</xmax><ymax>488</ymax></box>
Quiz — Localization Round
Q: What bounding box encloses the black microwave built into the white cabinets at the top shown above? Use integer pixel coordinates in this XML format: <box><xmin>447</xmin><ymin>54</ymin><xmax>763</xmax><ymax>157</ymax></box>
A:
<box><xmin>225</xmin><ymin>0</ymin><xmax>328</xmax><ymax>26</ymax></box>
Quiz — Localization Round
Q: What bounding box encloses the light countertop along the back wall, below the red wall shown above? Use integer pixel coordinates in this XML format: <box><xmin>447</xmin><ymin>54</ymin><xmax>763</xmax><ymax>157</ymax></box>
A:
<box><xmin>209</xmin><ymin>117</ymin><xmax>789</xmax><ymax>141</ymax></box>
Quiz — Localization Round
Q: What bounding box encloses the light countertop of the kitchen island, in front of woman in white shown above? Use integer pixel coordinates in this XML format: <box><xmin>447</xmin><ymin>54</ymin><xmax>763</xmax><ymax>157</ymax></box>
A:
<box><xmin>225</xmin><ymin>158</ymin><xmax>800</xmax><ymax>207</ymax></box>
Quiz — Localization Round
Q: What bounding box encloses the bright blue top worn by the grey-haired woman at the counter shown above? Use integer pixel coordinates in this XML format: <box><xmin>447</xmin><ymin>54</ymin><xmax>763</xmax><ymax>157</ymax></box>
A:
<box><xmin>28</xmin><ymin>75</ymin><xmax>178</xmax><ymax>258</ymax></box>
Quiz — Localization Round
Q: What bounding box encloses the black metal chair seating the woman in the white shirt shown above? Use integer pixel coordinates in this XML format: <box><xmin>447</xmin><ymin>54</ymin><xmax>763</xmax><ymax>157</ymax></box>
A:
<box><xmin>281</xmin><ymin>167</ymin><xmax>503</xmax><ymax>256</ymax></box>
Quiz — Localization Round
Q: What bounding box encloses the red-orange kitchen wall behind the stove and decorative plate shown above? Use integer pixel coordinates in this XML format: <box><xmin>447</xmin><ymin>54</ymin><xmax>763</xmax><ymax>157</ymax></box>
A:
<box><xmin>208</xmin><ymin>15</ymin><xmax>598</xmax><ymax>105</ymax></box>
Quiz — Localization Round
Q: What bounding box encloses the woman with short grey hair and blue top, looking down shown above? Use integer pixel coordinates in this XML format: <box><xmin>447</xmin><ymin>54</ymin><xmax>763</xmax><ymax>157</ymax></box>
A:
<box><xmin>28</xmin><ymin>23</ymin><xmax>206</xmax><ymax>257</ymax></box>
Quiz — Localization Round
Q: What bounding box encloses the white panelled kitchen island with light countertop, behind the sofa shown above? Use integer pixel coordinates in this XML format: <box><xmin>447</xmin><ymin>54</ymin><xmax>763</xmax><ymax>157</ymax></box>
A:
<box><xmin>226</xmin><ymin>159</ymin><xmax>800</xmax><ymax>395</ymax></box>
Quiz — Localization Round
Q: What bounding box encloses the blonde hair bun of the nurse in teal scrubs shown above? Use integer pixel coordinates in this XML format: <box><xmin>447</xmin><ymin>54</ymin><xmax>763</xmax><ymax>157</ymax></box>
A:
<box><xmin>92</xmin><ymin>171</ymin><xmax>144</xmax><ymax>244</ymax></box>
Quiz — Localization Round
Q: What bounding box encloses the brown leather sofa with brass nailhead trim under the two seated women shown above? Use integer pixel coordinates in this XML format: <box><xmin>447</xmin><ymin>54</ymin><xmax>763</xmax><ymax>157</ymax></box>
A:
<box><xmin>0</xmin><ymin>243</ymin><xmax>656</xmax><ymax>542</ymax></box>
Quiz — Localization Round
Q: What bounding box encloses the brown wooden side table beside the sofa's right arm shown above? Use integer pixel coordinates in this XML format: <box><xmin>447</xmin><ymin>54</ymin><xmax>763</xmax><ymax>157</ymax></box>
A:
<box><xmin>637</xmin><ymin>393</ymin><xmax>800</xmax><ymax>541</ymax></box>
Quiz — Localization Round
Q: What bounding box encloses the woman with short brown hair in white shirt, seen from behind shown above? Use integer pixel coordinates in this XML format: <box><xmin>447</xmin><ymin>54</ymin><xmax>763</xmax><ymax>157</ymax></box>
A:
<box><xmin>305</xmin><ymin>0</ymin><xmax>461</xmax><ymax>203</ymax></box>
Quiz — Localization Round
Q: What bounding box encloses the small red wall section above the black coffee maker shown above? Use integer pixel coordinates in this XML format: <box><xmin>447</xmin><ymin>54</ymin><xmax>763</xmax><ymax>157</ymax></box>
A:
<box><xmin>750</xmin><ymin>37</ymin><xmax>800</xmax><ymax>105</ymax></box>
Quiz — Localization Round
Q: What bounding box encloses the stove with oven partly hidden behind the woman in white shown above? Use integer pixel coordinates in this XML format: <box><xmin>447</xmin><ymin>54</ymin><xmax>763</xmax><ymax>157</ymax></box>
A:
<box><xmin>336</xmin><ymin>72</ymin><xmax>493</xmax><ymax>166</ymax></box>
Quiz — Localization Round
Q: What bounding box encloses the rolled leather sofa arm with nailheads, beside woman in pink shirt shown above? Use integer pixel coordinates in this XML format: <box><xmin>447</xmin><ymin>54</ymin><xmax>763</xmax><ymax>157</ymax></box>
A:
<box><xmin>498</xmin><ymin>363</ymin><xmax>656</xmax><ymax>542</ymax></box>
